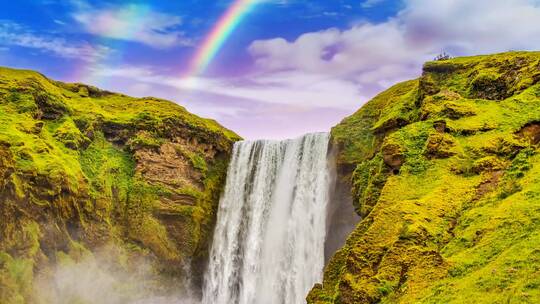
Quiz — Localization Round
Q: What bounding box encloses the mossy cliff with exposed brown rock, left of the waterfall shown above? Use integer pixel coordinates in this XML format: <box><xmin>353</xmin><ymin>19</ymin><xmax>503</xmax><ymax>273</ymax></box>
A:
<box><xmin>0</xmin><ymin>68</ymin><xmax>239</xmax><ymax>303</ymax></box>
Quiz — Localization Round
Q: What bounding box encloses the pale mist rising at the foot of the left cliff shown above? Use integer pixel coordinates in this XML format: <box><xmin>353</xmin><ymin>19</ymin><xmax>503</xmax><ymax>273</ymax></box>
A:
<box><xmin>34</xmin><ymin>248</ymin><xmax>200</xmax><ymax>304</ymax></box>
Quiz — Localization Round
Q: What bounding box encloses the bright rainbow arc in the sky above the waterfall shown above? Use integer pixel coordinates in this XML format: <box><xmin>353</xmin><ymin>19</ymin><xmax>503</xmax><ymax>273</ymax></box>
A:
<box><xmin>186</xmin><ymin>0</ymin><xmax>260</xmax><ymax>78</ymax></box>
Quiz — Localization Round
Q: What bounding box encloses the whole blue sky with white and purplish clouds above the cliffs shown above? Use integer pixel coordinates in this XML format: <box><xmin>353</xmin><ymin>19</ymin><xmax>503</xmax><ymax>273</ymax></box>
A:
<box><xmin>0</xmin><ymin>0</ymin><xmax>540</xmax><ymax>139</ymax></box>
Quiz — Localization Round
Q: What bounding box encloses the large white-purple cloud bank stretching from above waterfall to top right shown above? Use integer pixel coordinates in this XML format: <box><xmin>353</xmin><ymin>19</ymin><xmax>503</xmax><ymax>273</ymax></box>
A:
<box><xmin>66</xmin><ymin>0</ymin><xmax>540</xmax><ymax>138</ymax></box>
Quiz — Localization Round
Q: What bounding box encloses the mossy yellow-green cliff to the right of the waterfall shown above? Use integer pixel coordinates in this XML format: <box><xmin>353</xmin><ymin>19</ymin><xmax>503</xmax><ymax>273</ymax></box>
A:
<box><xmin>308</xmin><ymin>52</ymin><xmax>540</xmax><ymax>303</ymax></box>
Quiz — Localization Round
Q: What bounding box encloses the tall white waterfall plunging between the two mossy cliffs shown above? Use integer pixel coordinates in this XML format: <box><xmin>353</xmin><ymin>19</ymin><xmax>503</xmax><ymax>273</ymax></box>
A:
<box><xmin>203</xmin><ymin>133</ymin><xmax>330</xmax><ymax>304</ymax></box>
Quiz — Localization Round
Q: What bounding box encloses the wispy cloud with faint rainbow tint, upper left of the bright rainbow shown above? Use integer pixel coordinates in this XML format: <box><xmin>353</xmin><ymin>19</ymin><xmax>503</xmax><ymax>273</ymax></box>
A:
<box><xmin>72</xmin><ymin>1</ymin><xmax>193</xmax><ymax>48</ymax></box>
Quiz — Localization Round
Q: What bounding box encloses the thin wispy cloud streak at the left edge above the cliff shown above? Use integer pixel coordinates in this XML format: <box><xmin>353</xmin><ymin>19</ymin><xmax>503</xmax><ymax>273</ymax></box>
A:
<box><xmin>0</xmin><ymin>20</ymin><xmax>111</xmax><ymax>61</ymax></box>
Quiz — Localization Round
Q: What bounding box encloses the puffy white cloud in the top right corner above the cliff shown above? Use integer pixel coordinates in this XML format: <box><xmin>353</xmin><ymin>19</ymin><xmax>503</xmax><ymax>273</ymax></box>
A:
<box><xmin>398</xmin><ymin>0</ymin><xmax>540</xmax><ymax>54</ymax></box>
